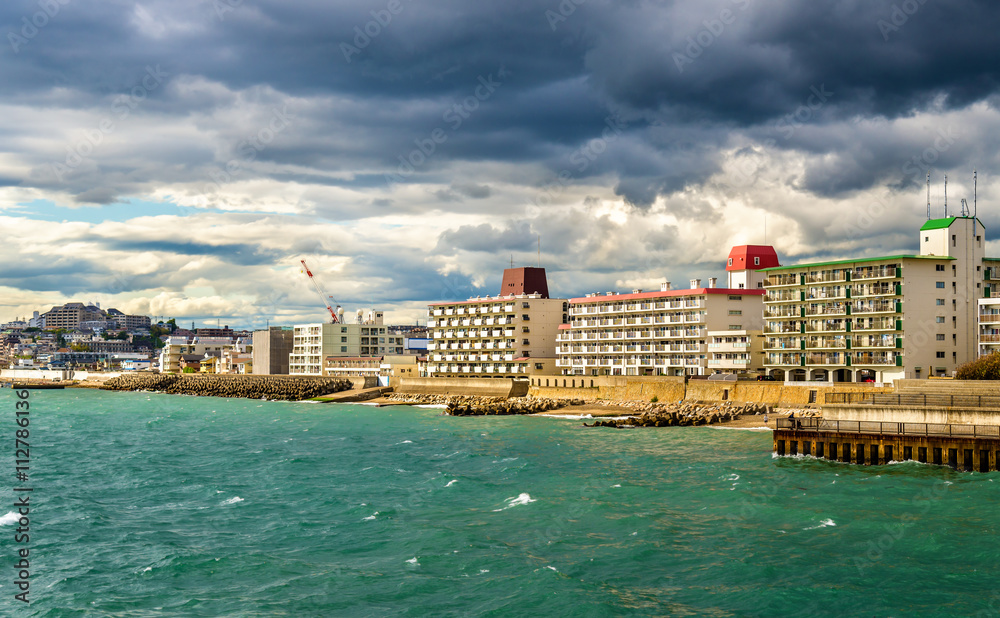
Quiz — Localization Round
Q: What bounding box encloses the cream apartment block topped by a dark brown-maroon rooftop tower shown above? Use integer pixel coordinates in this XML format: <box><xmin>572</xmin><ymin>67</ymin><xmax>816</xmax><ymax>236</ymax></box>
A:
<box><xmin>420</xmin><ymin>268</ymin><xmax>567</xmax><ymax>378</ymax></box>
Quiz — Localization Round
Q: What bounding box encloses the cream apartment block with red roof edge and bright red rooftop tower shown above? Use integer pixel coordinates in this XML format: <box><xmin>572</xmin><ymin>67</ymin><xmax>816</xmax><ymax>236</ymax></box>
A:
<box><xmin>558</xmin><ymin>245</ymin><xmax>778</xmax><ymax>376</ymax></box>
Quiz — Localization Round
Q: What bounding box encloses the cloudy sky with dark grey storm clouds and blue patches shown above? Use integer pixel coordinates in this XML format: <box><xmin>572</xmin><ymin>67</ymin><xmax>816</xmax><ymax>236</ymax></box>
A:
<box><xmin>0</xmin><ymin>0</ymin><xmax>1000</xmax><ymax>328</ymax></box>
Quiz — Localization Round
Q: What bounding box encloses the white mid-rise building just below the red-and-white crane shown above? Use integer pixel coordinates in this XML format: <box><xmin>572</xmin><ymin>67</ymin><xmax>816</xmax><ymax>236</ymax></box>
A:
<box><xmin>288</xmin><ymin>311</ymin><xmax>403</xmax><ymax>376</ymax></box>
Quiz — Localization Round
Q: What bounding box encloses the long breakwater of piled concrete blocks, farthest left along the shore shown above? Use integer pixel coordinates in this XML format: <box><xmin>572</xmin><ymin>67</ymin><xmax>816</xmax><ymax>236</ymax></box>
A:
<box><xmin>101</xmin><ymin>373</ymin><xmax>351</xmax><ymax>401</ymax></box>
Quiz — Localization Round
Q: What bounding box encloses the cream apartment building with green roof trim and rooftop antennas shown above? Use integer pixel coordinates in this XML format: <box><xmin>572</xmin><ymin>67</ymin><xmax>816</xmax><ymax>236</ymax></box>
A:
<box><xmin>764</xmin><ymin>216</ymin><xmax>991</xmax><ymax>382</ymax></box>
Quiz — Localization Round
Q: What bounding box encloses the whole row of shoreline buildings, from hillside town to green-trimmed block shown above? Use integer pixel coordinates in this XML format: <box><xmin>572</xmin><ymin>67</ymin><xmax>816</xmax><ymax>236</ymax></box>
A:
<box><xmin>7</xmin><ymin>214</ymin><xmax>1000</xmax><ymax>386</ymax></box>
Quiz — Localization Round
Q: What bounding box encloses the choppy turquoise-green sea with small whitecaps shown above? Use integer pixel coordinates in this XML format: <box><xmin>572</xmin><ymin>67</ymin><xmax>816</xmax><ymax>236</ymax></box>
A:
<box><xmin>0</xmin><ymin>389</ymin><xmax>1000</xmax><ymax>616</ymax></box>
